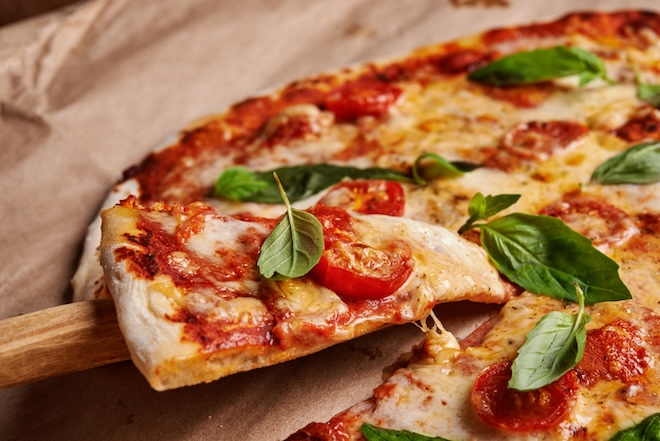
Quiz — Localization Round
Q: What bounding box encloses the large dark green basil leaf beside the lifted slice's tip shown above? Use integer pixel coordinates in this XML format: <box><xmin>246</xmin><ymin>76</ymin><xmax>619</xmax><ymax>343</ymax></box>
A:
<box><xmin>477</xmin><ymin>213</ymin><xmax>631</xmax><ymax>305</ymax></box>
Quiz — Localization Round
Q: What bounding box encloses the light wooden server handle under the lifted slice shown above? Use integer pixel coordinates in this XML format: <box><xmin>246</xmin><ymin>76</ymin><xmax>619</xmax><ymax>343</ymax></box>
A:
<box><xmin>0</xmin><ymin>299</ymin><xmax>130</xmax><ymax>388</ymax></box>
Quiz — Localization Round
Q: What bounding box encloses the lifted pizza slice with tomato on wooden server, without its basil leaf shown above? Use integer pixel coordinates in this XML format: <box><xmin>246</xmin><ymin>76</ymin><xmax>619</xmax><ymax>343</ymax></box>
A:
<box><xmin>100</xmin><ymin>191</ymin><xmax>513</xmax><ymax>390</ymax></box>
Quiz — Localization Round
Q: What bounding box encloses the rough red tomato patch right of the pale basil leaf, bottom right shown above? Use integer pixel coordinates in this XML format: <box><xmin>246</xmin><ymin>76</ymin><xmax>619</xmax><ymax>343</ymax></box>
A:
<box><xmin>575</xmin><ymin>319</ymin><xmax>650</xmax><ymax>387</ymax></box>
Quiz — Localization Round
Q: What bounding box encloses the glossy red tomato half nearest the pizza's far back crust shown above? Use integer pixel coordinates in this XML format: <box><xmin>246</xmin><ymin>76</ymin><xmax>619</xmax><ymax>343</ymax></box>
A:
<box><xmin>324</xmin><ymin>79</ymin><xmax>402</xmax><ymax>120</ymax></box>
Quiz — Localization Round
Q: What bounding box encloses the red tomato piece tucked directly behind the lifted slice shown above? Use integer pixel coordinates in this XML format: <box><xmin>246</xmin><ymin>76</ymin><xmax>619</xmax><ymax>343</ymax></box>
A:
<box><xmin>319</xmin><ymin>180</ymin><xmax>406</xmax><ymax>216</ymax></box>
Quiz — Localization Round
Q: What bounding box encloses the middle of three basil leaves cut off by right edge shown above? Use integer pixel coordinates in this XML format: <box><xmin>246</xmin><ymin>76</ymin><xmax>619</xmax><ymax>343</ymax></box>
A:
<box><xmin>591</xmin><ymin>142</ymin><xmax>660</xmax><ymax>185</ymax></box>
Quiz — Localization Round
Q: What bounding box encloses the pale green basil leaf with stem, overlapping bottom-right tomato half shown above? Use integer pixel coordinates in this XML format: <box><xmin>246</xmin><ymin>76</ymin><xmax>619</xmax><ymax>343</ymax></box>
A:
<box><xmin>509</xmin><ymin>284</ymin><xmax>591</xmax><ymax>391</ymax></box>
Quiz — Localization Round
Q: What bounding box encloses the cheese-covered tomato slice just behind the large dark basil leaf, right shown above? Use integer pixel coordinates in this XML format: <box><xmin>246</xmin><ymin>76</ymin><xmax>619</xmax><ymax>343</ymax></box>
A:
<box><xmin>540</xmin><ymin>192</ymin><xmax>639</xmax><ymax>249</ymax></box>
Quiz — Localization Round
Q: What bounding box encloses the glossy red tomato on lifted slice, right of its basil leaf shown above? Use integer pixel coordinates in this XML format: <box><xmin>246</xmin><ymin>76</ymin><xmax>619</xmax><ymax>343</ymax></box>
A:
<box><xmin>311</xmin><ymin>205</ymin><xmax>413</xmax><ymax>300</ymax></box>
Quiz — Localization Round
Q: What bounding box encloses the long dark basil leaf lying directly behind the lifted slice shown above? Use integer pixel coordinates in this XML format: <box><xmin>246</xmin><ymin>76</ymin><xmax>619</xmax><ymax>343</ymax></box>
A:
<box><xmin>215</xmin><ymin>164</ymin><xmax>412</xmax><ymax>204</ymax></box>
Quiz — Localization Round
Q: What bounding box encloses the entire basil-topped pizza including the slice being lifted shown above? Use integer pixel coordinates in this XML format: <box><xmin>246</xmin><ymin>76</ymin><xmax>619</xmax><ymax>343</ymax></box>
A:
<box><xmin>72</xmin><ymin>11</ymin><xmax>660</xmax><ymax>441</ymax></box>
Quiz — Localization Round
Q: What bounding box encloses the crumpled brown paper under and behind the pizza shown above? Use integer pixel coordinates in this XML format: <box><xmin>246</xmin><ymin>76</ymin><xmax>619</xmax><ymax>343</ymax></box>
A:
<box><xmin>0</xmin><ymin>0</ymin><xmax>656</xmax><ymax>441</ymax></box>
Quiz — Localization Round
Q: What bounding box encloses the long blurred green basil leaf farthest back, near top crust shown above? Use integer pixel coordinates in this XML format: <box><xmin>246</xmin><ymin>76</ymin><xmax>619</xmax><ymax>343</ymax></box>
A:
<box><xmin>468</xmin><ymin>46</ymin><xmax>612</xmax><ymax>87</ymax></box>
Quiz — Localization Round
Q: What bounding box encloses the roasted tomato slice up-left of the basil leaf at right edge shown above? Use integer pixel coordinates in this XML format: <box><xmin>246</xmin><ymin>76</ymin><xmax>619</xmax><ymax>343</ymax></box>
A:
<box><xmin>486</xmin><ymin>121</ymin><xmax>588</xmax><ymax>171</ymax></box>
